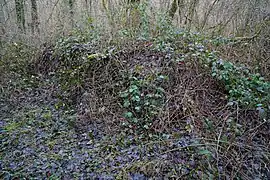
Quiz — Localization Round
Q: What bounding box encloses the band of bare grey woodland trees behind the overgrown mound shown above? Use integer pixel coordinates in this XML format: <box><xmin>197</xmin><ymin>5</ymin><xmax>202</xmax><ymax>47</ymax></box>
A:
<box><xmin>0</xmin><ymin>0</ymin><xmax>270</xmax><ymax>40</ymax></box>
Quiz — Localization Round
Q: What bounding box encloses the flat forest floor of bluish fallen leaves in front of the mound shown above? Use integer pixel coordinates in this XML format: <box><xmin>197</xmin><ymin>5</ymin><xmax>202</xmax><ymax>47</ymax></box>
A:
<box><xmin>0</xmin><ymin>73</ymin><xmax>210</xmax><ymax>179</ymax></box>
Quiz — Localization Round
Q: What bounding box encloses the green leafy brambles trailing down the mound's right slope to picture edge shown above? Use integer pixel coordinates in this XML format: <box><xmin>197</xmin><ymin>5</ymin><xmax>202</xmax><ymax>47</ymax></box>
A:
<box><xmin>181</xmin><ymin>37</ymin><xmax>270</xmax><ymax>110</ymax></box>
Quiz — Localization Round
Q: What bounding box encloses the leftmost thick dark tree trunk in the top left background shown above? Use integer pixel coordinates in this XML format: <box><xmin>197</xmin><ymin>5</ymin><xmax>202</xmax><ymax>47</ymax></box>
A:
<box><xmin>15</xmin><ymin>0</ymin><xmax>26</xmax><ymax>32</ymax></box>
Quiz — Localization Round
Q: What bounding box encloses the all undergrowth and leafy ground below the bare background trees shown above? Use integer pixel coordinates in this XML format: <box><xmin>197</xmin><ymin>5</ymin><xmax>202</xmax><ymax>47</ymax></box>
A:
<box><xmin>0</xmin><ymin>1</ymin><xmax>270</xmax><ymax>179</ymax></box>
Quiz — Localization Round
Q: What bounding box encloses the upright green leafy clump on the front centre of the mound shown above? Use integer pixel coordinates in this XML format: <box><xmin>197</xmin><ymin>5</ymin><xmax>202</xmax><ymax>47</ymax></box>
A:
<box><xmin>120</xmin><ymin>75</ymin><xmax>167</xmax><ymax>134</ymax></box>
